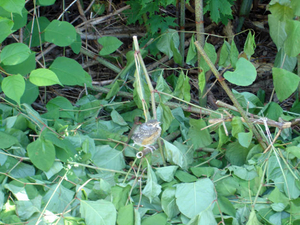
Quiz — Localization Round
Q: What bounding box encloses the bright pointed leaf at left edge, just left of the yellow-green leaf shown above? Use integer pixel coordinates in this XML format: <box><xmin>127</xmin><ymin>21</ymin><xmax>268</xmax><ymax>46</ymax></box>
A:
<box><xmin>1</xmin><ymin>74</ymin><xmax>25</xmax><ymax>104</ymax></box>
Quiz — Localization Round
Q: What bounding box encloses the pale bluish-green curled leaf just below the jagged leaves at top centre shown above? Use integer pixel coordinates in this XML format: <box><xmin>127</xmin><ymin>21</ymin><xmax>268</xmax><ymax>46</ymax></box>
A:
<box><xmin>156</xmin><ymin>29</ymin><xmax>179</xmax><ymax>59</ymax></box>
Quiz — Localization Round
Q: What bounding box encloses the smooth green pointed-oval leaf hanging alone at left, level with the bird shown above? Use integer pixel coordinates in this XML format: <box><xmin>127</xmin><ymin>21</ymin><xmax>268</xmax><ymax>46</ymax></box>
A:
<box><xmin>27</xmin><ymin>138</ymin><xmax>55</xmax><ymax>171</ymax></box>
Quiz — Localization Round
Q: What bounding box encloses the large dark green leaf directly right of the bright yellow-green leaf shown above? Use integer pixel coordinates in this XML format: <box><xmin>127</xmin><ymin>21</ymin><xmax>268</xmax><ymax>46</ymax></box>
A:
<box><xmin>50</xmin><ymin>57</ymin><xmax>91</xmax><ymax>86</ymax></box>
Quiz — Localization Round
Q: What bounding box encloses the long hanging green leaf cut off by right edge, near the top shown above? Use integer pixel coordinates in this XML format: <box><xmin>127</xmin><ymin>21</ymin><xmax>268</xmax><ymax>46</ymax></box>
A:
<box><xmin>284</xmin><ymin>20</ymin><xmax>300</xmax><ymax>57</ymax></box>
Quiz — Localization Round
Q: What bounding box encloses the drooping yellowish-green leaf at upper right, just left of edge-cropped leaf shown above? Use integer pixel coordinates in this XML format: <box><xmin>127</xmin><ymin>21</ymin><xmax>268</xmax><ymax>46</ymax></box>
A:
<box><xmin>268</xmin><ymin>14</ymin><xmax>287</xmax><ymax>50</ymax></box>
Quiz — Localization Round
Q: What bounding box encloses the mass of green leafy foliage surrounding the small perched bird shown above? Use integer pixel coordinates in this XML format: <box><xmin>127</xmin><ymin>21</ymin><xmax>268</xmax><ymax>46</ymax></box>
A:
<box><xmin>0</xmin><ymin>0</ymin><xmax>300</xmax><ymax>225</ymax></box>
